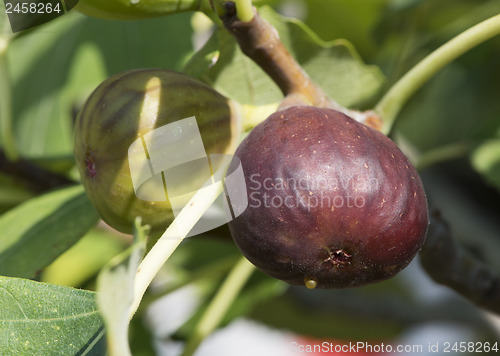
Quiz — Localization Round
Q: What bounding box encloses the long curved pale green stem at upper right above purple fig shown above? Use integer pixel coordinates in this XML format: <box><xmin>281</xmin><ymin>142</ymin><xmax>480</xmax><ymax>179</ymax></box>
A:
<box><xmin>375</xmin><ymin>15</ymin><xmax>500</xmax><ymax>135</ymax></box>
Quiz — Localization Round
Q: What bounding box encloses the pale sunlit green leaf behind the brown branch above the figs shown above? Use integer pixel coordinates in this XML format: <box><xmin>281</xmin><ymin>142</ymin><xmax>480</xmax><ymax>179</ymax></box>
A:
<box><xmin>184</xmin><ymin>7</ymin><xmax>384</xmax><ymax>121</ymax></box>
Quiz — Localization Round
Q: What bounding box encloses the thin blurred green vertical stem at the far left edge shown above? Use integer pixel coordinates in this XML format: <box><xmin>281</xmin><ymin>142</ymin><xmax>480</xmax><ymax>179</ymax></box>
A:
<box><xmin>0</xmin><ymin>31</ymin><xmax>19</xmax><ymax>161</ymax></box>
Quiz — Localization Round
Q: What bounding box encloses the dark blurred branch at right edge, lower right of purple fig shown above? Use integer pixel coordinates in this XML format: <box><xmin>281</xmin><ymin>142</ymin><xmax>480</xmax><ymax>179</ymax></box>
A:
<box><xmin>420</xmin><ymin>213</ymin><xmax>500</xmax><ymax>314</ymax></box>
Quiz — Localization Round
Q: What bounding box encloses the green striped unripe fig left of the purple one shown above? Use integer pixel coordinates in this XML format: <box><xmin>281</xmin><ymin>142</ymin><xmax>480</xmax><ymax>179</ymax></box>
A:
<box><xmin>74</xmin><ymin>69</ymin><xmax>239</xmax><ymax>233</ymax></box>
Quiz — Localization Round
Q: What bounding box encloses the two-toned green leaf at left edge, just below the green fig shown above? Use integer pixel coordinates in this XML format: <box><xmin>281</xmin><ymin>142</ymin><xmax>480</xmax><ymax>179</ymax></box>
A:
<box><xmin>0</xmin><ymin>186</ymin><xmax>98</xmax><ymax>278</ymax></box>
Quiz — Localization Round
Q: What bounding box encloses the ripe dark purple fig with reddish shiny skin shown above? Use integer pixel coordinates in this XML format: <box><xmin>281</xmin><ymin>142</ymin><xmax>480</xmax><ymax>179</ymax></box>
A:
<box><xmin>229</xmin><ymin>106</ymin><xmax>428</xmax><ymax>288</ymax></box>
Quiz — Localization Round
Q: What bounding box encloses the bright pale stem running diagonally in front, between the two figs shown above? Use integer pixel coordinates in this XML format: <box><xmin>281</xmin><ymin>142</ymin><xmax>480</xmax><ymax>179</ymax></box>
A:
<box><xmin>130</xmin><ymin>179</ymin><xmax>222</xmax><ymax>319</ymax></box>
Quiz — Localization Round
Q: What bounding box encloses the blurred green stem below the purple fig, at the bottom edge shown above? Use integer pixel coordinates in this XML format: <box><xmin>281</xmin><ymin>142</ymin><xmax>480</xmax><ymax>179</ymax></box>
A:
<box><xmin>182</xmin><ymin>257</ymin><xmax>255</xmax><ymax>356</ymax></box>
